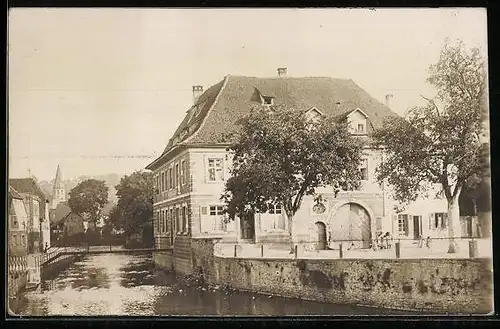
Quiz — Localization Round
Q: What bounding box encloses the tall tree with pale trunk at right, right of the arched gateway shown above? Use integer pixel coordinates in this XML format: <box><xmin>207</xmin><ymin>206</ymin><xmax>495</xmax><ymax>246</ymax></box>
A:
<box><xmin>374</xmin><ymin>40</ymin><xmax>487</xmax><ymax>253</ymax></box>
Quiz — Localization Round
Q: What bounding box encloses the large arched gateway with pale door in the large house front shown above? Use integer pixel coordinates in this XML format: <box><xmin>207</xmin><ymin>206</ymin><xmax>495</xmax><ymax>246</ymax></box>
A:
<box><xmin>330</xmin><ymin>202</ymin><xmax>372</xmax><ymax>248</ymax></box>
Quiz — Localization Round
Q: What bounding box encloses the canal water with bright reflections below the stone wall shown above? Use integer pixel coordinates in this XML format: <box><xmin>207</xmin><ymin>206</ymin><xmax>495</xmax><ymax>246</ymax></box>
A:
<box><xmin>11</xmin><ymin>254</ymin><xmax>418</xmax><ymax>316</ymax></box>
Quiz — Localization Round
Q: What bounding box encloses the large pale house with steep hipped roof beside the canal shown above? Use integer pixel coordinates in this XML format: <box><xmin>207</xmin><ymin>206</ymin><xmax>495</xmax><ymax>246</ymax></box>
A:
<box><xmin>146</xmin><ymin>68</ymin><xmax>454</xmax><ymax>266</ymax></box>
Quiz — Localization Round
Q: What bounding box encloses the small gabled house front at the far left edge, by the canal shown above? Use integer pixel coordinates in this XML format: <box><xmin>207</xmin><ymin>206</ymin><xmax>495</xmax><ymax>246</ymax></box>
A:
<box><xmin>8</xmin><ymin>185</ymin><xmax>28</xmax><ymax>256</ymax></box>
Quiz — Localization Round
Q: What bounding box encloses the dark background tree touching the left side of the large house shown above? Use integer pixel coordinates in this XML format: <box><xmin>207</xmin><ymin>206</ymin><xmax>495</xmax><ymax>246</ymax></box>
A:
<box><xmin>110</xmin><ymin>171</ymin><xmax>154</xmax><ymax>243</ymax></box>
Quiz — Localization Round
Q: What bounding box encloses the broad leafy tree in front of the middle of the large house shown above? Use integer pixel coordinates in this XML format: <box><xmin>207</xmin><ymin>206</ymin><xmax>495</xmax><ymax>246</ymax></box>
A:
<box><xmin>222</xmin><ymin>106</ymin><xmax>362</xmax><ymax>252</ymax></box>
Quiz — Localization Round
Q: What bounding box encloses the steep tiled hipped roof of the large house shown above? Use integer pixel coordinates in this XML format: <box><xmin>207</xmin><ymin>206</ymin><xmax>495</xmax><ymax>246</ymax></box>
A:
<box><xmin>147</xmin><ymin>75</ymin><xmax>396</xmax><ymax>169</ymax></box>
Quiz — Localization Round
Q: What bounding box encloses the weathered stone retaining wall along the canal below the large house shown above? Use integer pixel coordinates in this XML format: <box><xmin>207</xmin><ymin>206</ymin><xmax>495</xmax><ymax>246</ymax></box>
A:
<box><xmin>153</xmin><ymin>238</ymin><xmax>493</xmax><ymax>314</ymax></box>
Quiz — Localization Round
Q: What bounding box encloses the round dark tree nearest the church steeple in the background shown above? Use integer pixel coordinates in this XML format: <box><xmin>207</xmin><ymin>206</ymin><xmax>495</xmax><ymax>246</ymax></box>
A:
<box><xmin>68</xmin><ymin>179</ymin><xmax>108</xmax><ymax>229</ymax></box>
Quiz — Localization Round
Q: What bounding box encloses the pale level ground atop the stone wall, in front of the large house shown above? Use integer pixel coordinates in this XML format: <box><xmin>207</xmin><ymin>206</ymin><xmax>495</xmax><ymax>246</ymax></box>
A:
<box><xmin>214</xmin><ymin>239</ymin><xmax>492</xmax><ymax>259</ymax></box>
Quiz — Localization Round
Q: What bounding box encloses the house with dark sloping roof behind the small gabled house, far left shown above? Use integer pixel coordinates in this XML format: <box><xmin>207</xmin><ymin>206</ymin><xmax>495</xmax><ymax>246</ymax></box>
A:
<box><xmin>9</xmin><ymin>178</ymin><xmax>50</xmax><ymax>252</ymax></box>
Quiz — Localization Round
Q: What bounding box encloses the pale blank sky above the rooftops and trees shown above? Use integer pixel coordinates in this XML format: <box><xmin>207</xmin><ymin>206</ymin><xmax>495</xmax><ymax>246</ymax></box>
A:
<box><xmin>8</xmin><ymin>8</ymin><xmax>487</xmax><ymax>180</ymax></box>
